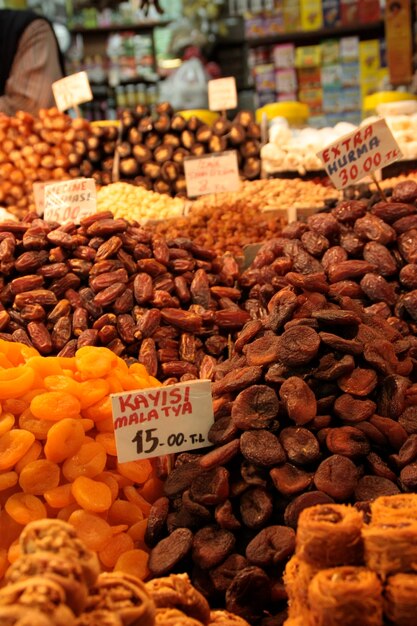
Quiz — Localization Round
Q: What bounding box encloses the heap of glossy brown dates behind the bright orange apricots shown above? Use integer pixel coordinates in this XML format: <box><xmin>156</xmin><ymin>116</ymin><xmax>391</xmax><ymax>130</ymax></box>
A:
<box><xmin>0</xmin><ymin>212</ymin><xmax>249</xmax><ymax>382</ymax></box>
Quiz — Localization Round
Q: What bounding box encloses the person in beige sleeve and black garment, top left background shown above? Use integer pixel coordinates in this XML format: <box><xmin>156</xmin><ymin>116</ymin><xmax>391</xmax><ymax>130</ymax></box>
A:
<box><xmin>0</xmin><ymin>9</ymin><xmax>65</xmax><ymax>115</ymax></box>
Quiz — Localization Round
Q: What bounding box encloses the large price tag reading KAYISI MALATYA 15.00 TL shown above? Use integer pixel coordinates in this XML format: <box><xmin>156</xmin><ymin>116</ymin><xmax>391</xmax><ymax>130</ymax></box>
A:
<box><xmin>111</xmin><ymin>380</ymin><xmax>214</xmax><ymax>463</ymax></box>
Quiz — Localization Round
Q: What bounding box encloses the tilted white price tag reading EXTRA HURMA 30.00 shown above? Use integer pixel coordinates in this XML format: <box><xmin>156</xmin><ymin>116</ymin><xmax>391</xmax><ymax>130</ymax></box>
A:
<box><xmin>317</xmin><ymin>119</ymin><xmax>403</xmax><ymax>189</ymax></box>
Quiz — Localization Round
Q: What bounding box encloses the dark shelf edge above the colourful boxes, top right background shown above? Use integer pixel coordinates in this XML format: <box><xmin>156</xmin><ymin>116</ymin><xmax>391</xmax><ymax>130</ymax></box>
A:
<box><xmin>218</xmin><ymin>20</ymin><xmax>384</xmax><ymax>48</ymax></box>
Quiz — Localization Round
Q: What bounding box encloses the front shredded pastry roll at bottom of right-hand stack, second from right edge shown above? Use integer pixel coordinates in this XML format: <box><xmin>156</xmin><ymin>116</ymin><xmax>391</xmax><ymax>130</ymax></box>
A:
<box><xmin>308</xmin><ymin>565</ymin><xmax>383</xmax><ymax>626</ymax></box>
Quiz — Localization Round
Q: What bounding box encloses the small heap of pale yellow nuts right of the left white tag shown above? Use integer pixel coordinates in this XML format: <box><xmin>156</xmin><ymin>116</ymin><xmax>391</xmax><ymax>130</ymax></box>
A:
<box><xmin>97</xmin><ymin>183</ymin><xmax>184</xmax><ymax>224</ymax></box>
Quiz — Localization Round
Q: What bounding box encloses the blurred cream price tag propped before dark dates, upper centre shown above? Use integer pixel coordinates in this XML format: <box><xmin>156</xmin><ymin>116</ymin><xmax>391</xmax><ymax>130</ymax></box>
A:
<box><xmin>184</xmin><ymin>150</ymin><xmax>240</xmax><ymax>198</ymax></box>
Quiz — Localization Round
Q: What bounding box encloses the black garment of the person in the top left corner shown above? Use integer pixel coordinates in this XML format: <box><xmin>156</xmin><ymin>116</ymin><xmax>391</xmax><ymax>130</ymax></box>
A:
<box><xmin>0</xmin><ymin>9</ymin><xmax>65</xmax><ymax>96</ymax></box>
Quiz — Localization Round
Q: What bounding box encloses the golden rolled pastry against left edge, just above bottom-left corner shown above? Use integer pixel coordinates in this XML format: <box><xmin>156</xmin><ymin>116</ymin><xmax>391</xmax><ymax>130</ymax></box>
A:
<box><xmin>0</xmin><ymin>576</ymin><xmax>75</xmax><ymax>626</ymax></box>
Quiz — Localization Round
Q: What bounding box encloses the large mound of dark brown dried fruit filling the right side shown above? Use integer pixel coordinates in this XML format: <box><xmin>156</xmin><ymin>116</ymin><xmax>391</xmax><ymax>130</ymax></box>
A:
<box><xmin>146</xmin><ymin>182</ymin><xmax>417</xmax><ymax>624</ymax></box>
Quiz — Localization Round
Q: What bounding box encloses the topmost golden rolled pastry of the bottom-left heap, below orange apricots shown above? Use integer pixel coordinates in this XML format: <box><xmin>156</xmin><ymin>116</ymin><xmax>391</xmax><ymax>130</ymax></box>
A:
<box><xmin>19</xmin><ymin>519</ymin><xmax>100</xmax><ymax>587</ymax></box>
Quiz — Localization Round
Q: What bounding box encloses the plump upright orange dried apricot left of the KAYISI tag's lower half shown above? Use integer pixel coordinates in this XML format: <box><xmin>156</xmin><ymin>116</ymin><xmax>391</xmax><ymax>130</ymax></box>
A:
<box><xmin>44</xmin><ymin>417</ymin><xmax>85</xmax><ymax>463</ymax></box>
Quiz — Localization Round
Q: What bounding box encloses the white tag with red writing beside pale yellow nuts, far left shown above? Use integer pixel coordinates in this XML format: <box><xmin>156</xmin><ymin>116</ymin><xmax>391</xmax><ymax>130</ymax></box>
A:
<box><xmin>44</xmin><ymin>178</ymin><xmax>97</xmax><ymax>224</ymax></box>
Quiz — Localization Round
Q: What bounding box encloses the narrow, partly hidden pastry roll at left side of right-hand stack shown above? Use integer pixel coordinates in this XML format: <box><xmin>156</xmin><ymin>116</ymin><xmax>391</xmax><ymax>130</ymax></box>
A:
<box><xmin>283</xmin><ymin>555</ymin><xmax>317</xmax><ymax>619</ymax></box>
